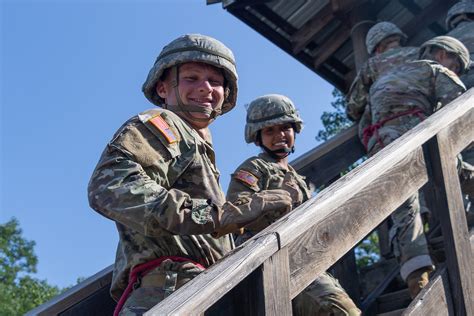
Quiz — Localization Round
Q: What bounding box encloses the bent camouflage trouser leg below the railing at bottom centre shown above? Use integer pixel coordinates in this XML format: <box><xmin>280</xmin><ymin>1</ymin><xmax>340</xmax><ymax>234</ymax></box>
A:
<box><xmin>292</xmin><ymin>273</ymin><xmax>361</xmax><ymax>316</ymax></box>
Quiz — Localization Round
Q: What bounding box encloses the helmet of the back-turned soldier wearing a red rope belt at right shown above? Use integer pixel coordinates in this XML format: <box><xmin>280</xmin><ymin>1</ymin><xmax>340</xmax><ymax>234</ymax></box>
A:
<box><xmin>420</xmin><ymin>35</ymin><xmax>471</xmax><ymax>74</ymax></box>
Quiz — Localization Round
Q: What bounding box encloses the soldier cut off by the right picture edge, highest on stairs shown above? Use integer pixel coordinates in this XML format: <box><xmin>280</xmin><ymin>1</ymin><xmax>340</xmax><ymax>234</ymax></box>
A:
<box><xmin>446</xmin><ymin>1</ymin><xmax>474</xmax><ymax>202</ymax></box>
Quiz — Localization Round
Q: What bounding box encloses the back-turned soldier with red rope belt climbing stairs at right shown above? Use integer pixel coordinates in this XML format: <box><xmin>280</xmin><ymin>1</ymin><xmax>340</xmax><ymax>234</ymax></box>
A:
<box><xmin>363</xmin><ymin>36</ymin><xmax>470</xmax><ymax>297</ymax></box>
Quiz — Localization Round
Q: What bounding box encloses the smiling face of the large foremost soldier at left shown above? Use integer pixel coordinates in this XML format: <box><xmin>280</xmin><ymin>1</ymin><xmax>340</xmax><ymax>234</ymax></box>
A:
<box><xmin>157</xmin><ymin>62</ymin><xmax>224</xmax><ymax>128</ymax></box>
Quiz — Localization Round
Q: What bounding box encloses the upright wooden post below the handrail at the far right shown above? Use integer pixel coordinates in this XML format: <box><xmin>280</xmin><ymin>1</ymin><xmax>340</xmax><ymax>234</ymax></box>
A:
<box><xmin>425</xmin><ymin>130</ymin><xmax>474</xmax><ymax>315</ymax></box>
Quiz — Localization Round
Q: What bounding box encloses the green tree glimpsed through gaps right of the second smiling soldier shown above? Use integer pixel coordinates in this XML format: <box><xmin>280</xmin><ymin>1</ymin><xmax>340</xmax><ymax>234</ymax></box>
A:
<box><xmin>316</xmin><ymin>89</ymin><xmax>380</xmax><ymax>267</ymax></box>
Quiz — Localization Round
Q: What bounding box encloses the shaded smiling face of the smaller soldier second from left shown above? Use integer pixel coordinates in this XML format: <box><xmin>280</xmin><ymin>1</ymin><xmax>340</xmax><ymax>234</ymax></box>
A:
<box><xmin>261</xmin><ymin>123</ymin><xmax>295</xmax><ymax>157</ymax></box>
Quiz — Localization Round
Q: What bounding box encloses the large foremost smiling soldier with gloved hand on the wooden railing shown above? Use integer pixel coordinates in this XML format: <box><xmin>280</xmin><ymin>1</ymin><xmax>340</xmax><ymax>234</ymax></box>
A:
<box><xmin>88</xmin><ymin>34</ymin><xmax>292</xmax><ymax>315</ymax></box>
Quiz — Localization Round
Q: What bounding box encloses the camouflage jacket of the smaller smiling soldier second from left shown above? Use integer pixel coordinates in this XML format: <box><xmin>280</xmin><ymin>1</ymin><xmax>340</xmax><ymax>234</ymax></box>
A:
<box><xmin>227</xmin><ymin>153</ymin><xmax>312</xmax><ymax>245</ymax></box>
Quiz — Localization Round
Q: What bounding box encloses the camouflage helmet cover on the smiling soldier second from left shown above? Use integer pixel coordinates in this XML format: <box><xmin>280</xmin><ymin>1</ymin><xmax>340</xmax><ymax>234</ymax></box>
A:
<box><xmin>245</xmin><ymin>94</ymin><xmax>303</xmax><ymax>143</ymax></box>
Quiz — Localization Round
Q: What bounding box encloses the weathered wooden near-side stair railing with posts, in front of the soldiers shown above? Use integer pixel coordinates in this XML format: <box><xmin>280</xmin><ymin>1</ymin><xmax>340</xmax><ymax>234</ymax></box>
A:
<box><xmin>145</xmin><ymin>89</ymin><xmax>474</xmax><ymax>315</ymax></box>
